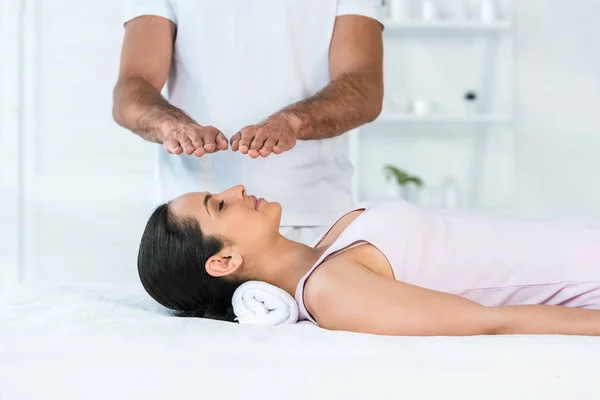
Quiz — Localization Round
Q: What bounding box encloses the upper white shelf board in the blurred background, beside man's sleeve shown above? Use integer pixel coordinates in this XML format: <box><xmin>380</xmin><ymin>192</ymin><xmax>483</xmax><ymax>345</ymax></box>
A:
<box><xmin>384</xmin><ymin>19</ymin><xmax>512</xmax><ymax>32</ymax></box>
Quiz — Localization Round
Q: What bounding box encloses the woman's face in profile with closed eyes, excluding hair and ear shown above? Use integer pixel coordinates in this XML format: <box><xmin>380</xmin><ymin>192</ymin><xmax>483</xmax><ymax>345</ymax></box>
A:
<box><xmin>170</xmin><ymin>186</ymin><xmax>281</xmax><ymax>255</ymax></box>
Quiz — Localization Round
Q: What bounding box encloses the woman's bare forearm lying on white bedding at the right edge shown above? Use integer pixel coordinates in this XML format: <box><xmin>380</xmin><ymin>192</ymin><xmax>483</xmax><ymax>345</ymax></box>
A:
<box><xmin>494</xmin><ymin>305</ymin><xmax>600</xmax><ymax>336</ymax></box>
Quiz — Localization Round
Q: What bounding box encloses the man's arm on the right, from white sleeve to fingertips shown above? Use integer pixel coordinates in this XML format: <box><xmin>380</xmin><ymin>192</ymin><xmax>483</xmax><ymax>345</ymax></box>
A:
<box><xmin>231</xmin><ymin>15</ymin><xmax>383</xmax><ymax>157</ymax></box>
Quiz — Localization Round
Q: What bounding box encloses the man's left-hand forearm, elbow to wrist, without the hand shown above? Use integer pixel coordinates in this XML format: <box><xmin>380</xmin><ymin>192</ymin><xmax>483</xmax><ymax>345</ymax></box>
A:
<box><xmin>113</xmin><ymin>78</ymin><xmax>194</xmax><ymax>143</ymax></box>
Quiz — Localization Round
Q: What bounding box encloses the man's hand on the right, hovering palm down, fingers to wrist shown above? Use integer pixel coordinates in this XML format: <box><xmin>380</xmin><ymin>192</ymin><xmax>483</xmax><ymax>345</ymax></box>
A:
<box><xmin>231</xmin><ymin>114</ymin><xmax>300</xmax><ymax>158</ymax></box>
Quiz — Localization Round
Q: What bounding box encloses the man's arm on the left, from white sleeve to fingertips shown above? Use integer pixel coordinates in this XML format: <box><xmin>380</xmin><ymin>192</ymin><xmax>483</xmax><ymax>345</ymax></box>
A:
<box><xmin>113</xmin><ymin>16</ymin><xmax>227</xmax><ymax>156</ymax></box>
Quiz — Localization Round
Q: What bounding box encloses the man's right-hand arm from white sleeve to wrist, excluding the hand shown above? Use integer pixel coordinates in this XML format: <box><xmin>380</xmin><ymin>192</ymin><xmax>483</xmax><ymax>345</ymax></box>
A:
<box><xmin>281</xmin><ymin>15</ymin><xmax>383</xmax><ymax>140</ymax></box>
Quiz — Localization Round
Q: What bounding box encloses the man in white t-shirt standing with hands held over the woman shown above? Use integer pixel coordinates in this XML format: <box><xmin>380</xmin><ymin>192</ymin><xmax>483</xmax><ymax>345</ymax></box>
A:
<box><xmin>113</xmin><ymin>0</ymin><xmax>383</xmax><ymax>243</ymax></box>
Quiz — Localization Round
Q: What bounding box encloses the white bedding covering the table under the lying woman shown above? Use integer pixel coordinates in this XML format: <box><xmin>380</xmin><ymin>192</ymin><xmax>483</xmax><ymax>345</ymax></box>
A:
<box><xmin>0</xmin><ymin>284</ymin><xmax>600</xmax><ymax>400</ymax></box>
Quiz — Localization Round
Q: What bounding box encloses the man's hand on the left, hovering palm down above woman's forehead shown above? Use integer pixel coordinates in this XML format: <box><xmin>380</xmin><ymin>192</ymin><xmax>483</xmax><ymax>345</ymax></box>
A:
<box><xmin>159</xmin><ymin>120</ymin><xmax>228</xmax><ymax>157</ymax></box>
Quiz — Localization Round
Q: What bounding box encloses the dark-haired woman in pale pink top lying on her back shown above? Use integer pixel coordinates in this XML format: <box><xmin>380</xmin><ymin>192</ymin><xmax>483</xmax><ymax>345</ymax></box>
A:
<box><xmin>138</xmin><ymin>186</ymin><xmax>600</xmax><ymax>336</ymax></box>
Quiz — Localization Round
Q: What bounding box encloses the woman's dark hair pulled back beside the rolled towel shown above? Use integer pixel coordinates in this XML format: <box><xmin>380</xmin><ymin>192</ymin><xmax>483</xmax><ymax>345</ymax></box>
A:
<box><xmin>138</xmin><ymin>203</ymin><xmax>239</xmax><ymax>321</ymax></box>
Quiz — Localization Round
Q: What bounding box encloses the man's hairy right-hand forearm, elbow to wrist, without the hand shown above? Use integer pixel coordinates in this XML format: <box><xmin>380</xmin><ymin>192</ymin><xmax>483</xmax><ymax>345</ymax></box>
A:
<box><xmin>275</xmin><ymin>70</ymin><xmax>383</xmax><ymax>140</ymax></box>
